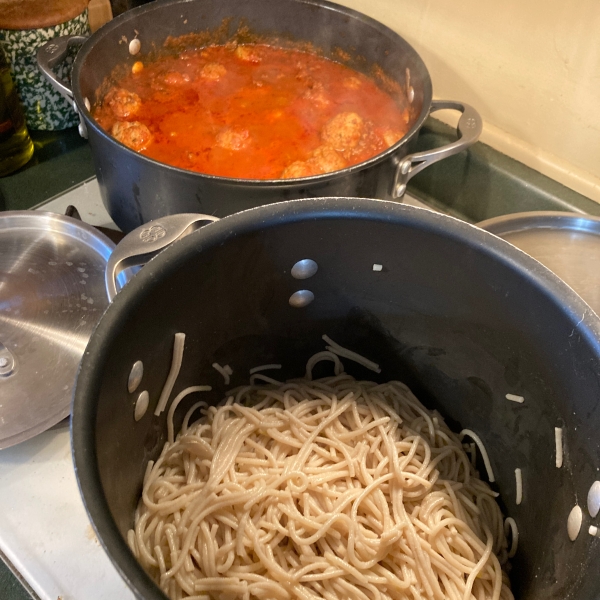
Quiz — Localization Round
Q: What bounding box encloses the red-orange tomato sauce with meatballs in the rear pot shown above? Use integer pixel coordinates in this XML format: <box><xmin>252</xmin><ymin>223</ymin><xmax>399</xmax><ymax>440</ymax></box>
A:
<box><xmin>92</xmin><ymin>44</ymin><xmax>408</xmax><ymax>179</ymax></box>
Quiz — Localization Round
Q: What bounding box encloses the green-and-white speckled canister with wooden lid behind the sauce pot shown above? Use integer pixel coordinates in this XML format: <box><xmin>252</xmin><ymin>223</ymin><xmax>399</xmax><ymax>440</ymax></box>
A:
<box><xmin>0</xmin><ymin>0</ymin><xmax>89</xmax><ymax>130</ymax></box>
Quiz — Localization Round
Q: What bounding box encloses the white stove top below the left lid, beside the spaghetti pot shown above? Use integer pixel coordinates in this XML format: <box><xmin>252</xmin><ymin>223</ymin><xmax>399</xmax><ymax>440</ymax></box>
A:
<box><xmin>0</xmin><ymin>419</ymin><xmax>134</xmax><ymax>600</ymax></box>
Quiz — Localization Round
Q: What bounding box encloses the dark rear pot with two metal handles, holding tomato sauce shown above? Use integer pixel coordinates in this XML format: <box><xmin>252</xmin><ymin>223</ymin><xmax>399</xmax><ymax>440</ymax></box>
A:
<box><xmin>38</xmin><ymin>0</ymin><xmax>481</xmax><ymax>231</ymax></box>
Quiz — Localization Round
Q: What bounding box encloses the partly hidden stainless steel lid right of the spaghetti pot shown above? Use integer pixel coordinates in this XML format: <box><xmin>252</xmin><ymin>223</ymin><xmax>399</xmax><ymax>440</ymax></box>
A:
<box><xmin>478</xmin><ymin>211</ymin><xmax>600</xmax><ymax>315</ymax></box>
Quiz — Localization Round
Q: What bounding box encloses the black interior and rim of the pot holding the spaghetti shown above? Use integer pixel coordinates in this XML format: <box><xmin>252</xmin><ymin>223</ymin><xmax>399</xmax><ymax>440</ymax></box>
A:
<box><xmin>73</xmin><ymin>199</ymin><xmax>600</xmax><ymax>600</ymax></box>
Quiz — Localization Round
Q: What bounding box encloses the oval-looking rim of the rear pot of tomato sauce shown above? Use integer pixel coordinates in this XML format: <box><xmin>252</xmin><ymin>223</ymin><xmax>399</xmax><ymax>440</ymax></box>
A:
<box><xmin>72</xmin><ymin>0</ymin><xmax>433</xmax><ymax>188</ymax></box>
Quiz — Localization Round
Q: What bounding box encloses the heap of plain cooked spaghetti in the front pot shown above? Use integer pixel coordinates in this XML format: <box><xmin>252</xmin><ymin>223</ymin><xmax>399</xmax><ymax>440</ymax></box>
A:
<box><xmin>128</xmin><ymin>352</ymin><xmax>513</xmax><ymax>600</ymax></box>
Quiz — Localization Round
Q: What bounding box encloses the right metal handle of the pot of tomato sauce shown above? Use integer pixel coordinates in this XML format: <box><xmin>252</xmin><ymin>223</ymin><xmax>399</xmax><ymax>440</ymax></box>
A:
<box><xmin>393</xmin><ymin>100</ymin><xmax>483</xmax><ymax>198</ymax></box>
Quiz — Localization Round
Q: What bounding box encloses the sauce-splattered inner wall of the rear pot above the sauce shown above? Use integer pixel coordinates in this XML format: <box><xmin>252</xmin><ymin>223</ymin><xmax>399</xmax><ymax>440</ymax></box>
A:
<box><xmin>73</xmin><ymin>0</ymin><xmax>432</xmax><ymax>143</ymax></box>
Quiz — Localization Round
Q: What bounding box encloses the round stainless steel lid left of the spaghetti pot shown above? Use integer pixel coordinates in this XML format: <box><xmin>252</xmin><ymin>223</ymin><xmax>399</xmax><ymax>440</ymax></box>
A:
<box><xmin>0</xmin><ymin>211</ymin><xmax>115</xmax><ymax>449</ymax></box>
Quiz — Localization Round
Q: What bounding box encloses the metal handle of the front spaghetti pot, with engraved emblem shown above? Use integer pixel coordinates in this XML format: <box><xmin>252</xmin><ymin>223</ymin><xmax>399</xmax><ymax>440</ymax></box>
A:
<box><xmin>105</xmin><ymin>213</ymin><xmax>219</xmax><ymax>302</ymax></box>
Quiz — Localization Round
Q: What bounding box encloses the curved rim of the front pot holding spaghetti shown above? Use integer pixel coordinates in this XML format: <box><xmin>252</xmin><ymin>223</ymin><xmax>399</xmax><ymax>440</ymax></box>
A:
<box><xmin>71</xmin><ymin>198</ymin><xmax>600</xmax><ymax>600</ymax></box>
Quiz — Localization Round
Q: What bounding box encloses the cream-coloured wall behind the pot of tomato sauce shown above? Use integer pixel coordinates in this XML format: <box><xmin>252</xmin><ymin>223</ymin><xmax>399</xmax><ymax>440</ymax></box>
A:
<box><xmin>337</xmin><ymin>0</ymin><xmax>600</xmax><ymax>201</ymax></box>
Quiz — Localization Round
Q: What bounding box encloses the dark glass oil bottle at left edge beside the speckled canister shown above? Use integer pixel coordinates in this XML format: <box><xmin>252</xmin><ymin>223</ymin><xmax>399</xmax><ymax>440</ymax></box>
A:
<box><xmin>0</xmin><ymin>47</ymin><xmax>33</xmax><ymax>177</ymax></box>
